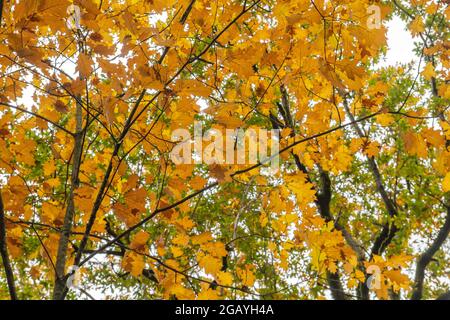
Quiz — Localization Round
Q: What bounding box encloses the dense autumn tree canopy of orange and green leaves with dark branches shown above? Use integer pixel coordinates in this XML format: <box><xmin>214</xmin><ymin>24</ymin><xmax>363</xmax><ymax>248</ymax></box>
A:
<box><xmin>0</xmin><ymin>0</ymin><xmax>450</xmax><ymax>299</ymax></box>
